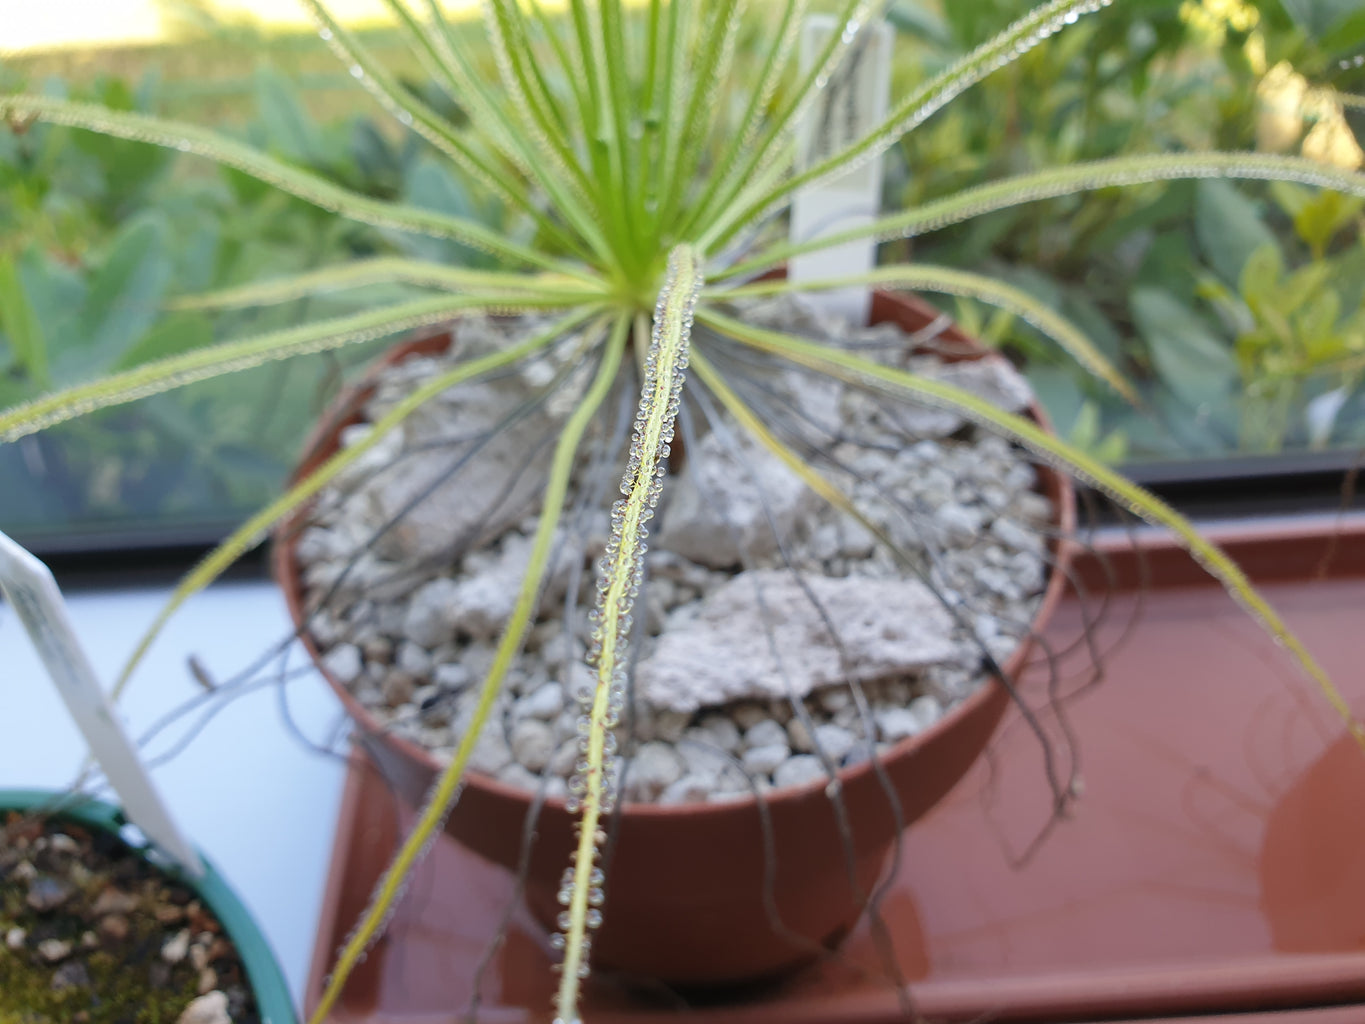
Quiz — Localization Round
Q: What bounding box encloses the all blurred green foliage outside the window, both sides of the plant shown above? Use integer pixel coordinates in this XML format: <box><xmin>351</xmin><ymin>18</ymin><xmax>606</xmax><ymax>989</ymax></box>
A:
<box><xmin>0</xmin><ymin>0</ymin><xmax>1365</xmax><ymax>538</ymax></box>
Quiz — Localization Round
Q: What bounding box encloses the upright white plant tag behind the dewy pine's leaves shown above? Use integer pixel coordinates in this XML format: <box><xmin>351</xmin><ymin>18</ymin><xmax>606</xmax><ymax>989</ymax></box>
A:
<box><xmin>788</xmin><ymin>15</ymin><xmax>894</xmax><ymax>325</ymax></box>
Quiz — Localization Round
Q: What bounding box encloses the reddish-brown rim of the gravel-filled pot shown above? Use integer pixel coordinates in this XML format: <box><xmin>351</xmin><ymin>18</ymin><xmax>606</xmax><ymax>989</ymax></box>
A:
<box><xmin>270</xmin><ymin>291</ymin><xmax>1076</xmax><ymax>821</ymax></box>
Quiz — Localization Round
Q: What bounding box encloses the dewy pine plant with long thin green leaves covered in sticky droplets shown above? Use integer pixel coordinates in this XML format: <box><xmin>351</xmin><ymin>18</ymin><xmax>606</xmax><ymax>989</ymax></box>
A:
<box><xmin>0</xmin><ymin>0</ymin><xmax>1365</xmax><ymax>1024</ymax></box>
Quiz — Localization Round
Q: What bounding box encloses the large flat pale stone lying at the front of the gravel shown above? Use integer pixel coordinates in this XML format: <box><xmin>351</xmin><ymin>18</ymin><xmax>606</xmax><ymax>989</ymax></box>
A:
<box><xmin>639</xmin><ymin>569</ymin><xmax>958</xmax><ymax>711</ymax></box>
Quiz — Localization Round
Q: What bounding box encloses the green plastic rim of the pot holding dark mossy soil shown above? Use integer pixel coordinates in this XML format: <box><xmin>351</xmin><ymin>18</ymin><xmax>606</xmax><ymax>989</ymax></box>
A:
<box><xmin>0</xmin><ymin>789</ymin><xmax>299</xmax><ymax>1024</ymax></box>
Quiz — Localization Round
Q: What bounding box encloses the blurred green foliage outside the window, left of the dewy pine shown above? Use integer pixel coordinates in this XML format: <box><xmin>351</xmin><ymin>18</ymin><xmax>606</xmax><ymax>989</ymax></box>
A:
<box><xmin>0</xmin><ymin>62</ymin><xmax>513</xmax><ymax>542</ymax></box>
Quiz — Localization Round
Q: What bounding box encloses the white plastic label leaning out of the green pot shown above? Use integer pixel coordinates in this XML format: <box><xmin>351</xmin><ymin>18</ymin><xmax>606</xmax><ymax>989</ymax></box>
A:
<box><xmin>0</xmin><ymin>532</ymin><xmax>203</xmax><ymax>878</ymax></box>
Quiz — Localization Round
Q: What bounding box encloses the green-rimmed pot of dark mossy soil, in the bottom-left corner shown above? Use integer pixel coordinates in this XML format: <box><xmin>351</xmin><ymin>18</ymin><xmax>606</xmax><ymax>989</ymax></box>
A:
<box><xmin>0</xmin><ymin>791</ymin><xmax>295</xmax><ymax>1024</ymax></box>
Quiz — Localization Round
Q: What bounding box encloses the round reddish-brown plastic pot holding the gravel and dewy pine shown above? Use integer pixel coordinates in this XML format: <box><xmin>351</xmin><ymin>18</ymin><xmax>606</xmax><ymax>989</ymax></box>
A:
<box><xmin>274</xmin><ymin>292</ymin><xmax>1074</xmax><ymax>986</ymax></box>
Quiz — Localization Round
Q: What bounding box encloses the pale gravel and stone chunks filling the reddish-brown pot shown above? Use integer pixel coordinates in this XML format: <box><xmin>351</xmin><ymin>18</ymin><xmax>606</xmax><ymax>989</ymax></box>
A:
<box><xmin>298</xmin><ymin>300</ymin><xmax>1052</xmax><ymax>803</ymax></box>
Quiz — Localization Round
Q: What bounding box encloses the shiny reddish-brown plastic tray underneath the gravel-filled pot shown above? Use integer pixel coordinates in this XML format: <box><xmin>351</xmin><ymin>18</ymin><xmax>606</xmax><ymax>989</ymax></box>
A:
<box><xmin>306</xmin><ymin>517</ymin><xmax>1365</xmax><ymax>1024</ymax></box>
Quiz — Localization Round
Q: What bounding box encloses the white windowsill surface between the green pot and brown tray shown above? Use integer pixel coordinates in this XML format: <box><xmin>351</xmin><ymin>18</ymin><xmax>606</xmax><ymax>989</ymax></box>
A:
<box><xmin>0</xmin><ymin>582</ymin><xmax>344</xmax><ymax>1006</ymax></box>
